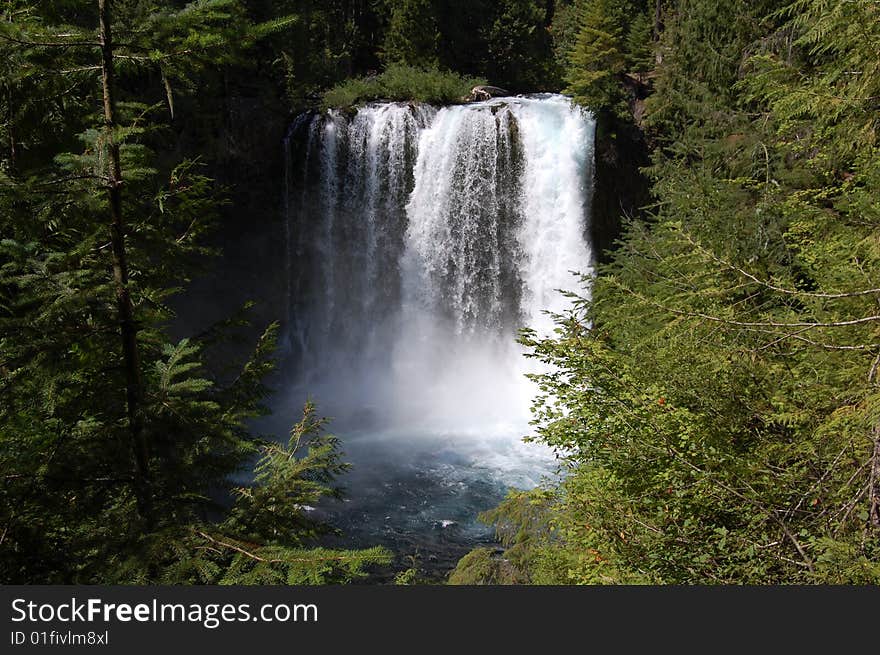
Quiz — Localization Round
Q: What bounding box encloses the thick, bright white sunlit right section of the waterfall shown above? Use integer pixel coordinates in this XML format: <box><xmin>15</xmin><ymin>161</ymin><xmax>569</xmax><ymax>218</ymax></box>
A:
<box><xmin>394</xmin><ymin>96</ymin><xmax>593</xmax><ymax>439</ymax></box>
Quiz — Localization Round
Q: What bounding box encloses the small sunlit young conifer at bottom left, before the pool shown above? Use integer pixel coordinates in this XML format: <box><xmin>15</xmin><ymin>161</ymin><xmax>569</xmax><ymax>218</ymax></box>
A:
<box><xmin>132</xmin><ymin>403</ymin><xmax>390</xmax><ymax>584</ymax></box>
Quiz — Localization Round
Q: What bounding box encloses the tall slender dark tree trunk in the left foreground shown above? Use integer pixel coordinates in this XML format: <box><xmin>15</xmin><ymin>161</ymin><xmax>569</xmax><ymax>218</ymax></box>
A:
<box><xmin>98</xmin><ymin>0</ymin><xmax>153</xmax><ymax>524</ymax></box>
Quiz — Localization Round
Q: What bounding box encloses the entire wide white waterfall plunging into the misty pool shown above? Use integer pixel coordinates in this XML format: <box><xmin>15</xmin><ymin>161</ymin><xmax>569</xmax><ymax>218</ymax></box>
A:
<box><xmin>284</xmin><ymin>94</ymin><xmax>595</xmax><ymax>446</ymax></box>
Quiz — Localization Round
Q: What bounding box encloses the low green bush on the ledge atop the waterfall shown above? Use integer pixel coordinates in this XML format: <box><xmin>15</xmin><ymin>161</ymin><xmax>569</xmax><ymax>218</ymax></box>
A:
<box><xmin>323</xmin><ymin>64</ymin><xmax>486</xmax><ymax>108</ymax></box>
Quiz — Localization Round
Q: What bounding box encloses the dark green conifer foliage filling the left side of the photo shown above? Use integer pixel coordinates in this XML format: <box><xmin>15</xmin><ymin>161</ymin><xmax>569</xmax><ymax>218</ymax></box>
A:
<box><xmin>0</xmin><ymin>0</ymin><xmax>387</xmax><ymax>583</ymax></box>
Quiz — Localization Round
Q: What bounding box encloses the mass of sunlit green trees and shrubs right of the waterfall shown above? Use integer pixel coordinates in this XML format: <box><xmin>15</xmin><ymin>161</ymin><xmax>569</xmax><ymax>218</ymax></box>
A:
<box><xmin>459</xmin><ymin>0</ymin><xmax>880</xmax><ymax>584</ymax></box>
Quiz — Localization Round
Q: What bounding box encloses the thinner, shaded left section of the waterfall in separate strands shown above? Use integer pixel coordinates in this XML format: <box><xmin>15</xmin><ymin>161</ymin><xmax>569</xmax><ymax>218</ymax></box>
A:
<box><xmin>289</xmin><ymin>104</ymin><xmax>433</xmax><ymax>384</ymax></box>
